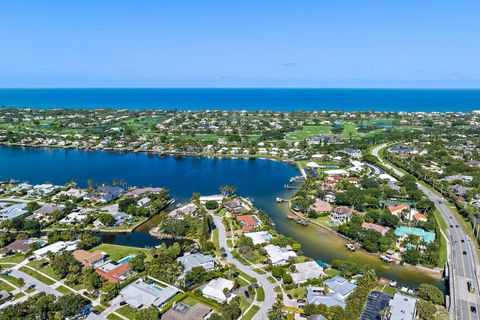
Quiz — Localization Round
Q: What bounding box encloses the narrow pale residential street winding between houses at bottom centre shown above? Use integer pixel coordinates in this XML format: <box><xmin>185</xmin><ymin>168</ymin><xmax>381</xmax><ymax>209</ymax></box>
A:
<box><xmin>213</xmin><ymin>215</ymin><xmax>277</xmax><ymax>320</ymax></box>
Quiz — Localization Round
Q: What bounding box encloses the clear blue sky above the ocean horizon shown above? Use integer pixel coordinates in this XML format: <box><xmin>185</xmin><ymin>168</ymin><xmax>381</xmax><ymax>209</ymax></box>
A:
<box><xmin>0</xmin><ymin>0</ymin><xmax>480</xmax><ymax>88</ymax></box>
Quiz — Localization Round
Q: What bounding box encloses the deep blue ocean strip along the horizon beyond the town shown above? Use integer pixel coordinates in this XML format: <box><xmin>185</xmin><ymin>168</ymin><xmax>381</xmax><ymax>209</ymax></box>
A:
<box><xmin>0</xmin><ymin>88</ymin><xmax>480</xmax><ymax>112</ymax></box>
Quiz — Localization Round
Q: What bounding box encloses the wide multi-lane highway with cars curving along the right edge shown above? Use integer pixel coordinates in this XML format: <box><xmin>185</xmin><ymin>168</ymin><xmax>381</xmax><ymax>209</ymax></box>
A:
<box><xmin>372</xmin><ymin>144</ymin><xmax>480</xmax><ymax>320</ymax></box>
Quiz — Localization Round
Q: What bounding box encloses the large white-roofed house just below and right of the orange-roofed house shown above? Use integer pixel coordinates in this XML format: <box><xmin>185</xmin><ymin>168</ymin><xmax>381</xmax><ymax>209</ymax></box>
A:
<box><xmin>120</xmin><ymin>279</ymin><xmax>178</xmax><ymax>309</ymax></box>
